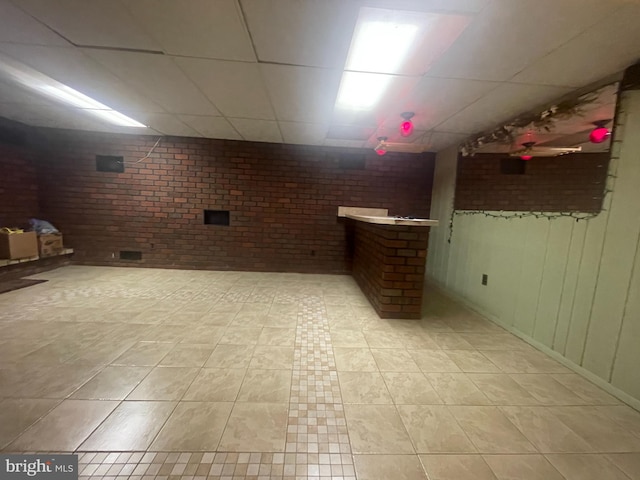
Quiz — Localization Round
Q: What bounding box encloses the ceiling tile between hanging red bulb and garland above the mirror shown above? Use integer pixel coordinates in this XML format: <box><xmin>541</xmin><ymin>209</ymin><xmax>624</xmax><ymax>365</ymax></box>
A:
<box><xmin>437</xmin><ymin>83</ymin><xmax>571</xmax><ymax>134</ymax></box>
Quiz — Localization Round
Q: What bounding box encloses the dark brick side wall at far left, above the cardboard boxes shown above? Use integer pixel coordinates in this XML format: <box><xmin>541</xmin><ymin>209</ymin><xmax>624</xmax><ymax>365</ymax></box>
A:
<box><xmin>0</xmin><ymin>143</ymin><xmax>39</xmax><ymax>227</ymax></box>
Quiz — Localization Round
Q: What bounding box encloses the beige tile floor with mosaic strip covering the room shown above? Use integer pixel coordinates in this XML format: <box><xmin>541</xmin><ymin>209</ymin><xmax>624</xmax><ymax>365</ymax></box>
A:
<box><xmin>0</xmin><ymin>267</ymin><xmax>640</xmax><ymax>480</ymax></box>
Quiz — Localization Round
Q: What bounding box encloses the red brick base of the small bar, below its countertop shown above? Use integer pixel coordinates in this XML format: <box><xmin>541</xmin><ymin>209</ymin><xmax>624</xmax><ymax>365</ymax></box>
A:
<box><xmin>348</xmin><ymin>220</ymin><xmax>429</xmax><ymax>319</ymax></box>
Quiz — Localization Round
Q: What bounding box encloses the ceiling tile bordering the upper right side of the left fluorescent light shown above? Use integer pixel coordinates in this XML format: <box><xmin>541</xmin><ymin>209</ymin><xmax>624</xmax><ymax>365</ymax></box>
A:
<box><xmin>0</xmin><ymin>43</ymin><xmax>163</xmax><ymax>112</ymax></box>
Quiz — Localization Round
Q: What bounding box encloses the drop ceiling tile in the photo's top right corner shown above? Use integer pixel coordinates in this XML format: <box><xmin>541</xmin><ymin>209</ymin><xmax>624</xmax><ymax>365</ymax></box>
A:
<box><xmin>511</xmin><ymin>4</ymin><xmax>640</xmax><ymax>87</ymax></box>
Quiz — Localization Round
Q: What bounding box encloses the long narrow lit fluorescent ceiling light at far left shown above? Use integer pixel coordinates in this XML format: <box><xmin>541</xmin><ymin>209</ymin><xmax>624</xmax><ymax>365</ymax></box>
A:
<box><xmin>0</xmin><ymin>54</ymin><xmax>146</xmax><ymax>128</ymax></box>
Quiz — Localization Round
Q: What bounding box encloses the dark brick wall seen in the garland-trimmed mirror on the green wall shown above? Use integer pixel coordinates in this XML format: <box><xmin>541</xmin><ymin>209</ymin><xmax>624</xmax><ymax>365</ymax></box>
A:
<box><xmin>455</xmin><ymin>153</ymin><xmax>609</xmax><ymax>212</ymax></box>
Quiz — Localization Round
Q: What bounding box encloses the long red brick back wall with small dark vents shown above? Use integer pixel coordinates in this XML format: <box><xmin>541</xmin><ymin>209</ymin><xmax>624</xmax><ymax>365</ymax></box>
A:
<box><xmin>33</xmin><ymin>130</ymin><xmax>434</xmax><ymax>272</ymax></box>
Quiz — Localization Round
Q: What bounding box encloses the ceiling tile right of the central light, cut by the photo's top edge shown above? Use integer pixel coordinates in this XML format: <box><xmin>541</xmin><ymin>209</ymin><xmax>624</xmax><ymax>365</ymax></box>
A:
<box><xmin>429</xmin><ymin>0</ymin><xmax>615</xmax><ymax>81</ymax></box>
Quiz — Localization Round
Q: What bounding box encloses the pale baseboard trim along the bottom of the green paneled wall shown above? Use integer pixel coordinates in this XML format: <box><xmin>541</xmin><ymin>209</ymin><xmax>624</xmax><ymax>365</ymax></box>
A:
<box><xmin>426</xmin><ymin>277</ymin><xmax>640</xmax><ymax>411</ymax></box>
